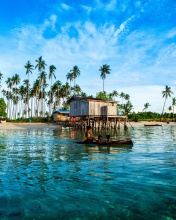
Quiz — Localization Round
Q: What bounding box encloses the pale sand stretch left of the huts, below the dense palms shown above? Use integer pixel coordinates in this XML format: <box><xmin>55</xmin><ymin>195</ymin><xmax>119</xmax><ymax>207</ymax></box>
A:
<box><xmin>0</xmin><ymin>122</ymin><xmax>61</xmax><ymax>130</ymax></box>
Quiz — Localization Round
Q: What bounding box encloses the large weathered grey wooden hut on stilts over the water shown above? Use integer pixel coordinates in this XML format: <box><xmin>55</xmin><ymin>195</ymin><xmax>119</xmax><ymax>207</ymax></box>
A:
<box><xmin>69</xmin><ymin>97</ymin><xmax>126</xmax><ymax>128</ymax></box>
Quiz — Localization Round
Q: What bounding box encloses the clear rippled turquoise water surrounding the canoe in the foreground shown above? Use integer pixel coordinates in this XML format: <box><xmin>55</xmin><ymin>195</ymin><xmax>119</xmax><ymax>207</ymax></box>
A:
<box><xmin>0</xmin><ymin>125</ymin><xmax>176</xmax><ymax>220</ymax></box>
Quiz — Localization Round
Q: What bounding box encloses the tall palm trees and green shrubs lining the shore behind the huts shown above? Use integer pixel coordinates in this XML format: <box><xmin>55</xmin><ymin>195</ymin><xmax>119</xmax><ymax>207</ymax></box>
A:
<box><xmin>0</xmin><ymin>56</ymin><xmax>176</xmax><ymax>122</ymax></box>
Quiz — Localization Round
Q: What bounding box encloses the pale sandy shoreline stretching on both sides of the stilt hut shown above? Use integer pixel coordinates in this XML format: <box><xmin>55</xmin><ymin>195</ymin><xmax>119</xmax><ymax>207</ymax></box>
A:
<box><xmin>0</xmin><ymin>121</ymin><xmax>176</xmax><ymax>130</ymax></box>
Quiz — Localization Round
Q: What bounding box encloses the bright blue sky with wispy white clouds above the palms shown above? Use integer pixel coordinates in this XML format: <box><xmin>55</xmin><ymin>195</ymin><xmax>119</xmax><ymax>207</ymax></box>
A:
<box><xmin>0</xmin><ymin>0</ymin><xmax>176</xmax><ymax>112</ymax></box>
